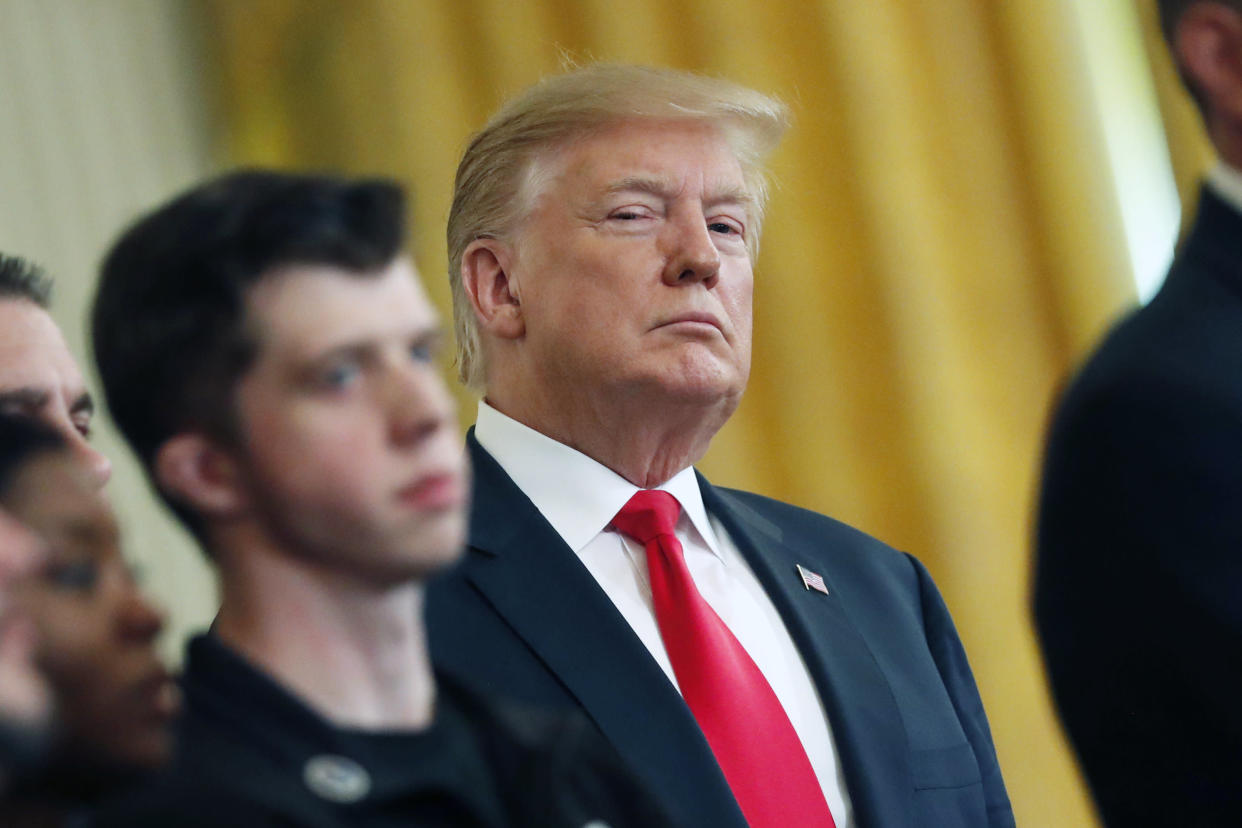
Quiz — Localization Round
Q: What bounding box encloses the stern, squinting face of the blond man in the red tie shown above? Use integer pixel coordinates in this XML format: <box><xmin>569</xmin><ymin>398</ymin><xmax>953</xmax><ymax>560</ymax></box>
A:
<box><xmin>510</xmin><ymin>120</ymin><xmax>754</xmax><ymax>410</ymax></box>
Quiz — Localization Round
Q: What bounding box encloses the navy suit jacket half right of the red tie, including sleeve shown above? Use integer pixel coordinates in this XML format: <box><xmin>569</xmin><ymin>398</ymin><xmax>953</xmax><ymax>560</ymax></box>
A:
<box><xmin>703</xmin><ymin>480</ymin><xmax>1013</xmax><ymax>826</ymax></box>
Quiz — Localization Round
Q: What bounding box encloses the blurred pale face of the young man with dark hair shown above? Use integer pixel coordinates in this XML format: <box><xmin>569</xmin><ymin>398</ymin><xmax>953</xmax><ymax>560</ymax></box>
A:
<box><xmin>236</xmin><ymin>258</ymin><xmax>467</xmax><ymax>583</ymax></box>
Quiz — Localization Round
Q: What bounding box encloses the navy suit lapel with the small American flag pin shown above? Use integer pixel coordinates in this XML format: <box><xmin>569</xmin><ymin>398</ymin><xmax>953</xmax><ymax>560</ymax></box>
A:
<box><xmin>699</xmin><ymin>475</ymin><xmax>913</xmax><ymax>826</ymax></box>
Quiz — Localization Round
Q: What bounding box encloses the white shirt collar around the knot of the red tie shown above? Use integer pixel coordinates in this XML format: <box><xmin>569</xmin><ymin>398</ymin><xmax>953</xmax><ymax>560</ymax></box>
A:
<box><xmin>474</xmin><ymin>400</ymin><xmax>720</xmax><ymax>557</ymax></box>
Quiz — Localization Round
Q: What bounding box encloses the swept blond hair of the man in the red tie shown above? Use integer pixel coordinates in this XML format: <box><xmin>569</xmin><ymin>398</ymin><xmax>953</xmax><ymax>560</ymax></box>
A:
<box><xmin>447</xmin><ymin>63</ymin><xmax>789</xmax><ymax>391</ymax></box>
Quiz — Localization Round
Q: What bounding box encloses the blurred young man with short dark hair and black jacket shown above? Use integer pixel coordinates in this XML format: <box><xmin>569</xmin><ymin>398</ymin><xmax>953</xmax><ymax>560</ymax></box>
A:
<box><xmin>93</xmin><ymin>171</ymin><xmax>661</xmax><ymax>828</ymax></box>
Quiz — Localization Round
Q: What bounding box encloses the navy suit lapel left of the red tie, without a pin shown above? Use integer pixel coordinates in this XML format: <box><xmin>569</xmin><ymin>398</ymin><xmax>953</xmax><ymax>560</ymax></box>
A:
<box><xmin>465</xmin><ymin>432</ymin><xmax>744</xmax><ymax>826</ymax></box>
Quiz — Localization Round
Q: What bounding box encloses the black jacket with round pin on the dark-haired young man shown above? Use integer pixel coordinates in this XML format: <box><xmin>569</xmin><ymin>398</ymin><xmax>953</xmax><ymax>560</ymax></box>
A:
<box><xmin>96</xmin><ymin>636</ymin><xmax>667</xmax><ymax>828</ymax></box>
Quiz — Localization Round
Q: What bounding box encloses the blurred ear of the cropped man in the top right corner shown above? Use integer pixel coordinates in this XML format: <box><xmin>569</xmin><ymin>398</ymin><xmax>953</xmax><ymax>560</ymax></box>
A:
<box><xmin>1174</xmin><ymin>2</ymin><xmax>1242</xmax><ymax>123</ymax></box>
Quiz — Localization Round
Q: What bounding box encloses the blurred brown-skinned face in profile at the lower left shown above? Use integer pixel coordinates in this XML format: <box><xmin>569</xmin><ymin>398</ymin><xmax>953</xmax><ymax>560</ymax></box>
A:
<box><xmin>6</xmin><ymin>452</ymin><xmax>178</xmax><ymax>770</ymax></box>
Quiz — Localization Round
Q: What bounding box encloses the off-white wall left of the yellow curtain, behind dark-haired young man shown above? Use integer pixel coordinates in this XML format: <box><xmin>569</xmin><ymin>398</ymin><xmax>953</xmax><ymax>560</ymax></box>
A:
<box><xmin>0</xmin><ymin>0</ymin><xmax>215</xmax><ymax>658</ymax></box>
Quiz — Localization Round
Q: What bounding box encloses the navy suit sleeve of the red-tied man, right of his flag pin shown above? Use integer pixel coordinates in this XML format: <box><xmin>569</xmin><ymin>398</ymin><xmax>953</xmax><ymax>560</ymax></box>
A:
<box><xmin>910</xmin><ymin>557</ymin><xmax>1015</xmax><ymax>828</ymax></box>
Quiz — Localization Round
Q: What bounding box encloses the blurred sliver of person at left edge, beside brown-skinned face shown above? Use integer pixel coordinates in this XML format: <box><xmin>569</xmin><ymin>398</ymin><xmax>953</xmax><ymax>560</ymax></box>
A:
<box><xmin>0</xmin><ymin>506</ymin><xmax>52</xmax><ymax>794</ymax></box>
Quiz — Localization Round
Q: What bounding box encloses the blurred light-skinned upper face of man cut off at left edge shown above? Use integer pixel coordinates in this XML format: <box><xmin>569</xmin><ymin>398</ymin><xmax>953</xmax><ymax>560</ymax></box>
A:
<box><xmin>0</xmin><ymin>299</ymin><xmax>112</xmax><ymax>487</ymax></box>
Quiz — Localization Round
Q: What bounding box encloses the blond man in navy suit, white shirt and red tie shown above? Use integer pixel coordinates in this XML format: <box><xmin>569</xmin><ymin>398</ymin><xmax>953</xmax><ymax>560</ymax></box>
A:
<box><xmin>428</xmin><ymin>66</ymin><xmax>1013</xmax><ymax>828</ymax></box>
